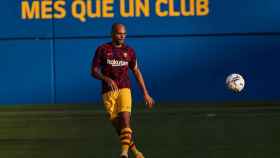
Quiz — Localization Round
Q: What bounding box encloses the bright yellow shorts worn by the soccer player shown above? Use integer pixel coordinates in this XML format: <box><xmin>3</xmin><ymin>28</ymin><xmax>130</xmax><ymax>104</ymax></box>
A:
<box><xmin>102</xmin><ymin>88</ymin><xmax>132</xmax><ymax>120</ymax></box>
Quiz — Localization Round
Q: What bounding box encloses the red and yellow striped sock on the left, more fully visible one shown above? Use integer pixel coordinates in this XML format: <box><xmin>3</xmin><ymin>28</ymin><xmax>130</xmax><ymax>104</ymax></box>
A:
<box><xmin>120</xmin><ymin>128</ymin><xmax>132</xmax><ymax>152</ymax></box>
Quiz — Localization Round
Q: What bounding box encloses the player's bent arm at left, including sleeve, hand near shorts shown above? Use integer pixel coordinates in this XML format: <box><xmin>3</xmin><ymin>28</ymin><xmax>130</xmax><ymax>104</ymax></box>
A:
<box><xmin>91</xmin><ymin>47</ymin><xmax>118</xmax><ymax>91</ymax></box>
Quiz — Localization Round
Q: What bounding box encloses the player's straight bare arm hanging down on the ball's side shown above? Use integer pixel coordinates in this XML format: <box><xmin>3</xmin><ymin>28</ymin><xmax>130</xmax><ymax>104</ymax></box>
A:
<box><xmin>132</xmin><ymin>66</ymin><xmax>155</xmax><ymax>108</ymax></box>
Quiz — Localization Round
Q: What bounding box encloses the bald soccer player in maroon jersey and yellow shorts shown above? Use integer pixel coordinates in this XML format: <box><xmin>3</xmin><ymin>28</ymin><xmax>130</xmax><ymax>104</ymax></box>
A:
<box><xmin>92</xmin><ymin>23</ymin><xmax>154</xmax><ymax>158</ymax></box>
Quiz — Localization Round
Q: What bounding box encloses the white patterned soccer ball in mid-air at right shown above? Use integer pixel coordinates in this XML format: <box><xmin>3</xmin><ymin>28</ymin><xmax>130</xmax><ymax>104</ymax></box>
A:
<box><xmin>226</xmin><ymin>73</ymin><xmax>245</xmax><ymax>92</ymax></box>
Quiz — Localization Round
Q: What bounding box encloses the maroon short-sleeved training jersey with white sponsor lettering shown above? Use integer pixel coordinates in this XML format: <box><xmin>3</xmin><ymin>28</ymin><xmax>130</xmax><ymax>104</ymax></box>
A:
<box><xmin>92</xmin><ymin>43</ymin><xmax>137</xmax><ymax>93</ymax></box>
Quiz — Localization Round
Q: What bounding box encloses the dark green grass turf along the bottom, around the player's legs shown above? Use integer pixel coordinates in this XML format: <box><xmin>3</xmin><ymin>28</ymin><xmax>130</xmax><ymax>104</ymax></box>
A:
<box><xmin>0</xmin><ymin>105</ymin><xmax>280</xmax><ymax>158</ymax></box>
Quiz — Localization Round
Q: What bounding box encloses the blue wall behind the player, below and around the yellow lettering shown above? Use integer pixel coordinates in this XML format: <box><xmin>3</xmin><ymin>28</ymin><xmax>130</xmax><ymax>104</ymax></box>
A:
<box><xmin>0</xmin><ymin>0</ymin><xmax>280</xmax><ymax>105</ymax></box>
